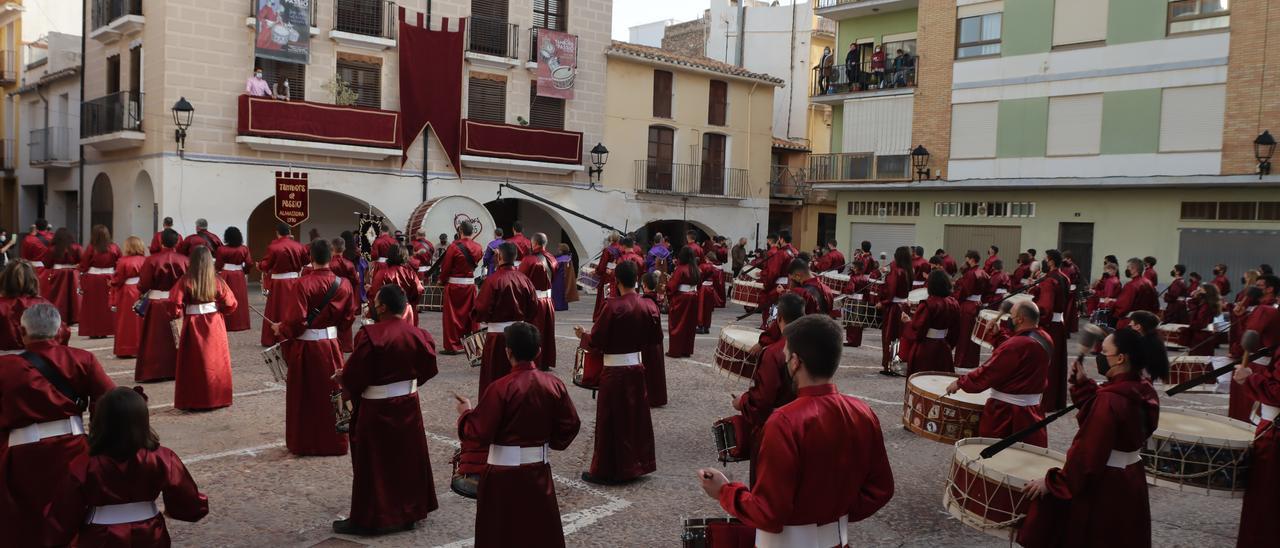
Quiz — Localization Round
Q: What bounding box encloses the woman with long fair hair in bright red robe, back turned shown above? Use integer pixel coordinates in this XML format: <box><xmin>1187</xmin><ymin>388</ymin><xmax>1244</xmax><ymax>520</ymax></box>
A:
<box><xmin>168</xmin><ymin>246</ymin><xmax>239</xmax><ymax>410</ymax></box>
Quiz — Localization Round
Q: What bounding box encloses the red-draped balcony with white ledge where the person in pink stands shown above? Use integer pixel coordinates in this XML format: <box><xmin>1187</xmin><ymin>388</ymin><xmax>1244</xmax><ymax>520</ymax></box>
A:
<box><xmin>236</xmin><ymin>95</ymin><xmax>402</xmax><ymax>160</ymax></box>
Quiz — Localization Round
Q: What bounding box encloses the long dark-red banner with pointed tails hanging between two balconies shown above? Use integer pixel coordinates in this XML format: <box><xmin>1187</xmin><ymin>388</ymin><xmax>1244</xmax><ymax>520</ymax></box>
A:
<box><xmin>397</xmin><ymin>8</ymin><xmax>467</xmax><ymax>175</ymax></box>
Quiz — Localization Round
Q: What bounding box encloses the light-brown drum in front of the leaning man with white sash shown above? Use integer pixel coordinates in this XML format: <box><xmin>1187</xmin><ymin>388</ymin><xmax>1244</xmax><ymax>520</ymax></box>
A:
<box><xmin>902</xmin><ymin>371</ymin><xmax>991</xmax><ymax>443</ymax></box>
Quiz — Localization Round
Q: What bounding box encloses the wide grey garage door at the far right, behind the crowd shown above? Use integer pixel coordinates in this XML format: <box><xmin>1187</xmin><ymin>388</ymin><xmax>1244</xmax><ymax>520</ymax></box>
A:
<box><xmin>1177</xmin><ymin>228</ymin><xmax>1280</xmax><ymax>292</ymax></box>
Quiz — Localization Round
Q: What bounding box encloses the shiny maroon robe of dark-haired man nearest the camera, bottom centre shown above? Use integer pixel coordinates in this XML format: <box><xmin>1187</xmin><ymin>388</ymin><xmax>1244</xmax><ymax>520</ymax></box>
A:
<box><xmin>719</xmin><ymin>384</ymin><xmax>893</xmax><ymax>544</ymax></box>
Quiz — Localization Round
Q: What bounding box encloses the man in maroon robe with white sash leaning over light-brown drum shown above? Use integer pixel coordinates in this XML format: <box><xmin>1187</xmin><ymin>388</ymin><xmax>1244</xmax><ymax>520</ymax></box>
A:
<box><xmin>947</xmin><ymin>301</ymin><xmax>1053</xmax><ymax>447</ymax></box>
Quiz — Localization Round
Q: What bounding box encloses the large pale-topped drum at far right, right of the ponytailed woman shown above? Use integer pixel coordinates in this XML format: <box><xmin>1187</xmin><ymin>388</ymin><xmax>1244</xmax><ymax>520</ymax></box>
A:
<box><xmin>1140</xmin><ymin>408</ymin><xmax>1253</xmax><ymax>498</ymax></box>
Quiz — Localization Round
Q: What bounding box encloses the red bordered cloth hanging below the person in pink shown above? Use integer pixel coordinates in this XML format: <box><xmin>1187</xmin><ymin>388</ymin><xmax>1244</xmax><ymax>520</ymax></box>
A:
<box><xmin>237</xmin><ymin>95</ymin><xmax>402</xmax><ymax>149</ymax></box>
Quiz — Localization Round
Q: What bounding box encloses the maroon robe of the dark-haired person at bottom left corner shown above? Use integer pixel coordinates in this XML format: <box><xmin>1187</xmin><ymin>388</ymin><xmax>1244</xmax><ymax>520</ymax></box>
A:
<box><xmin>76</xmin><ymin>447</ymin><xmax>209</xmax><ymax>548</ymax></box>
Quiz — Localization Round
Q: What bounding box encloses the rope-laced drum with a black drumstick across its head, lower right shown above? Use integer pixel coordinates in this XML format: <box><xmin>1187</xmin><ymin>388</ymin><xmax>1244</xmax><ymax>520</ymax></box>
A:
<box><xmin>942</xmin><ymin>438</ymin><xmax>1066</xmax><ymax>539</ymax></box>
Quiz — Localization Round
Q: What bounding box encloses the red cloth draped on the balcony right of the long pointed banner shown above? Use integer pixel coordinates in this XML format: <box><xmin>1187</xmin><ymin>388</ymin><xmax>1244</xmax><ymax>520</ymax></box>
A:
<box><xmin>462</xmin><ymin>120</ymin><xmax>582</xmax><ymax>164</ymax></box>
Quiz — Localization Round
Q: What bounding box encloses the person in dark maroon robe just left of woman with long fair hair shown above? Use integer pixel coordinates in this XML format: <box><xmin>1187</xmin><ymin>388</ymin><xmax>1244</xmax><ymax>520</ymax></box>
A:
<box><xmin>135</xmin><ymin>230</ymin><xmax>188</xmax><ymax>383</ymax></box>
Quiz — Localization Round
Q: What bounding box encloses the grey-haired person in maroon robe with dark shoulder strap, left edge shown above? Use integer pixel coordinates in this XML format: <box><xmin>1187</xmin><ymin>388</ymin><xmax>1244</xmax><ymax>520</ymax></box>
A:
<box><xmin>0</xmin><ymin>303</ymin><xmax>115</xmax><ymax>547</ymax></box>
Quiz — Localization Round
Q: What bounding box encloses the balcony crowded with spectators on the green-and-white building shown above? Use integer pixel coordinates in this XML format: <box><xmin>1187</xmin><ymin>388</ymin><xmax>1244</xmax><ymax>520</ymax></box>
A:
<box><xmin>809</xmin><ymin>55</ymin><xmax>920</xmax><ymax>105</ymax></box>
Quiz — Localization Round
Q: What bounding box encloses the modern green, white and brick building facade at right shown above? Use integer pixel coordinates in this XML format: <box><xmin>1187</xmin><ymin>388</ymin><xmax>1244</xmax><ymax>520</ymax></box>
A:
<box><xmin>810</xmin><ymin>0</ymin><xmax>1280</xmax><ymax>282</ymax></box>
